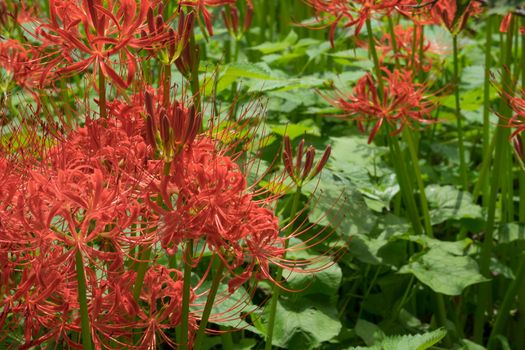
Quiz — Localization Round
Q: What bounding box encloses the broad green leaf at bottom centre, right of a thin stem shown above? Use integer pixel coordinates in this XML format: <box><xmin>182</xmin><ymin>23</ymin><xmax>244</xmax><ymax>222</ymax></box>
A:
<box><xmin>273</xmin><ymin>302</ymin><xmax>342</xmax><ymax>349</ymax></box>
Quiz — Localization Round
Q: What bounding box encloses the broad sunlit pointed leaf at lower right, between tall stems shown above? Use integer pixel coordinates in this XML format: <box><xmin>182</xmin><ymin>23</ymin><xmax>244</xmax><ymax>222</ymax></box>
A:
<box><xmin>399</xmin><ymin>248</ymin><xmax>488</xmax><ymax>295</ymax></box>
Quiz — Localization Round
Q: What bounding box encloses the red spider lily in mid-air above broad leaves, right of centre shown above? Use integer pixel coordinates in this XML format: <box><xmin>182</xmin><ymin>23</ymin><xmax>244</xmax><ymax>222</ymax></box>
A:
<box><xmin>327</xmin><ymin>68</ymin><xmax>434</xmax><ymax>143</ymax></box>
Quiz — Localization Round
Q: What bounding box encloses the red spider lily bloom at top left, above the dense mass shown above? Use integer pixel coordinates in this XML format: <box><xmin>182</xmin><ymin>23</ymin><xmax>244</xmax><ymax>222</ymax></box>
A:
<box><xmin>36</xmin><ymin>0</ymin><xmax>169</xmax><ymax>88</ymax></box>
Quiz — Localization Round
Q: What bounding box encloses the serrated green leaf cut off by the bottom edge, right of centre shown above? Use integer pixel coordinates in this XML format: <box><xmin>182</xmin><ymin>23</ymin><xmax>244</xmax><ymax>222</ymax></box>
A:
<box><xmin>349</xmin><ymin>328</ymin><xmax>447</xmax><ymax>350</ymax></box>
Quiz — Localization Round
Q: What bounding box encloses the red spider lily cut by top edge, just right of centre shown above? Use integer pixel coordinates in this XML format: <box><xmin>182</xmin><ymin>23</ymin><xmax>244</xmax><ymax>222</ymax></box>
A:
<box><xmin>307</xmin><ymin>0</ymin><xmax>402</xmax><ymax>46</ymax></box>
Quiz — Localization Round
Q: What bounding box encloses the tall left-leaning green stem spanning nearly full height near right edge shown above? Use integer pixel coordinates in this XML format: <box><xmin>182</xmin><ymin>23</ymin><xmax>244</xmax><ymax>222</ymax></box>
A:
<box><xmin>474</xmin><ymin>15</ymin><xmax>514</xmax><ymax>343</ymax></box>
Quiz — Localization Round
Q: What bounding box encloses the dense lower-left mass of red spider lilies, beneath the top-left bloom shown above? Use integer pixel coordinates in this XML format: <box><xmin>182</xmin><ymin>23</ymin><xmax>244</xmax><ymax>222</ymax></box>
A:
<box><xmin>0</xmin><ymin>89</ymin><xmax>326</xmax><ymax>349</ymax></box>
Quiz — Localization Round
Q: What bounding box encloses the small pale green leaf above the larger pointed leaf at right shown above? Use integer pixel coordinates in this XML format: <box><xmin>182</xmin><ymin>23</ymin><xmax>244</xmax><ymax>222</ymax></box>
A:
<box><xmin>425</xmin><ymin>185</ymin><xmax>483</xmax><ymax>225</ymax></box>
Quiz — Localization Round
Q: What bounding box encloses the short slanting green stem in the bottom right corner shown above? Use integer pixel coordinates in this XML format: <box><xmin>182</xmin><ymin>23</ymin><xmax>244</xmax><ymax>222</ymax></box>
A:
<box><xmin>488</xmin><ymin>252</ymin><xmax>525</xmax><ymax>350</ymax></box>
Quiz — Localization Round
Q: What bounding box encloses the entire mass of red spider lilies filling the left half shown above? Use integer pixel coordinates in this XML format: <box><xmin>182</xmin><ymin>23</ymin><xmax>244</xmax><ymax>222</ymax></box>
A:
<box><xmin>0</xmin><ymin>0</ymin><xmax>331</xmax><ymax>349</ymax></box>
